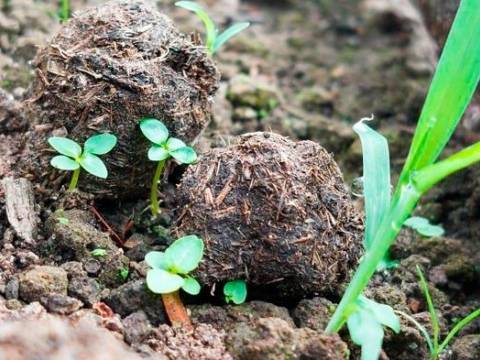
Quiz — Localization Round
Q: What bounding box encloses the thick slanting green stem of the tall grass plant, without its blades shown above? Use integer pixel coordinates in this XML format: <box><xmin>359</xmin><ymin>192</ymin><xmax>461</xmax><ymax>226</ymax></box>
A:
<box><xmin>326</xmin><ymin>185</ymin><xmax>420</xmax><ymax>333</ymax></box>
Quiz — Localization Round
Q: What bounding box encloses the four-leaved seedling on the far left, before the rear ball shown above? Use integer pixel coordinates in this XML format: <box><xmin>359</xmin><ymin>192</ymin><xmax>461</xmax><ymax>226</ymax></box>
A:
<box><xmin>48</xmin><ymin>134</ymin><xmax>117</xmax><ymax>191</ymax></box>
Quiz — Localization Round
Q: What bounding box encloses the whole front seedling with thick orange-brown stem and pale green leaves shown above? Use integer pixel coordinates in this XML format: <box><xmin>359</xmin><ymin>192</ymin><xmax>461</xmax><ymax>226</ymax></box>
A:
<box><xmin>145</xmin><ymin>235</ymin><xmax>204</xmax><ymax>329</ymax></box>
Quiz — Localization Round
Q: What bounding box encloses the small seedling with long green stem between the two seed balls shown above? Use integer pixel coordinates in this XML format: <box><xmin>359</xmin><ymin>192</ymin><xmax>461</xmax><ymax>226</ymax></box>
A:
<box><xmin>140</xmin><ymin>118</ymin><xmax>197</xmax><ymax>216</ymax></box>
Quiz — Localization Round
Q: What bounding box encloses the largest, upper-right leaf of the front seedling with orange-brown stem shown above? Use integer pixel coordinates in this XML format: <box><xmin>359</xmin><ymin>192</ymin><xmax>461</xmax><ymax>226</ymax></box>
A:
<box><xmin>165</xmin><ymin>235</ymin><xmax>204</xmax><ymax>274</ymax></box>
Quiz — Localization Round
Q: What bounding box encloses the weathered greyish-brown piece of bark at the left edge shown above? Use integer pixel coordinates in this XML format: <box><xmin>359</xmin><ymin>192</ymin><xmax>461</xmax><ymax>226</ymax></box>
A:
<box><xmin>1</xmin><ymin>177</ymin><xmax>37</xmax><ymax>245</ymax></box>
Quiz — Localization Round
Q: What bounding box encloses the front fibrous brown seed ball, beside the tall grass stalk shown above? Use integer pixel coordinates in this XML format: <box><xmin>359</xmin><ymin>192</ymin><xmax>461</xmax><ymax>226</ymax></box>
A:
<box><xmin>174</xmin><ymin>133</ymin><xmax>363</xmax><ymax>296</ymax></box>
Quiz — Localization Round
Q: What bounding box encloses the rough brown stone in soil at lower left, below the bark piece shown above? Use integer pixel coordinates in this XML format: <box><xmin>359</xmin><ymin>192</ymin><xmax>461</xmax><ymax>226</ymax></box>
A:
<box><xmin>19</xmin><ymin>266</ymin><xmax>68</xmax><ymax>302</ymax></box>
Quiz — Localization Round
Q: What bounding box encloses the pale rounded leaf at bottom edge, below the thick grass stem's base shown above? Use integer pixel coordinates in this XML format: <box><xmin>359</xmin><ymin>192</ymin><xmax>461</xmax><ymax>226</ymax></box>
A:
<box><xmin>347</xmin><ymin>309</ymin><xmax>383</xmax><ymax>360</ymax></box>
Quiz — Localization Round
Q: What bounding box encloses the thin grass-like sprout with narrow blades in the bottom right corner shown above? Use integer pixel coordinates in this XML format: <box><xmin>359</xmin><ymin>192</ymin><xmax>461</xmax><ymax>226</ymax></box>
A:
<box><xmin>397</xmin><ymin>265</ymin><xmax>480</xmax><ymax>360</ymax></box>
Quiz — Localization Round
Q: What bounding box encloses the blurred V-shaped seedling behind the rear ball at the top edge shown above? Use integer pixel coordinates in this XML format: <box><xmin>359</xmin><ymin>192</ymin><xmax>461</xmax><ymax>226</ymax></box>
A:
<box><xmin>175</xmin><ymin>1</ymin><xmax>250</xmax><ymax>56</ymax></box>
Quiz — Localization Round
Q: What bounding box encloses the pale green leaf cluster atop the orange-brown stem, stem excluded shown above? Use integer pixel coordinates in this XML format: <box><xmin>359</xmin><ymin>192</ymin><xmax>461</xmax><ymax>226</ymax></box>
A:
<box><xmin>145</xmin><ymin>235</ymin><xmax>204</xmax><ymax>295</ymax></box>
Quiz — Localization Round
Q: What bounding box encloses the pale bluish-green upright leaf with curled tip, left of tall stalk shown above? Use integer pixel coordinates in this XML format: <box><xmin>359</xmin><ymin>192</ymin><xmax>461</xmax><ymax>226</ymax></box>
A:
<box><xmin>353</xmin><ymin>119</ymin><xmax>391</xmax><ymax>250</ymax></box>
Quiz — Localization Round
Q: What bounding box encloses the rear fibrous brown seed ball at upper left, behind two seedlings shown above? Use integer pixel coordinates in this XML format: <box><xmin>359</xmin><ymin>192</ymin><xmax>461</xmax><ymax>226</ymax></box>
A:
<box><xmin>23</xmin><ymin>1</ymin><xmax>219</xmax><ymax>197</ymax></box>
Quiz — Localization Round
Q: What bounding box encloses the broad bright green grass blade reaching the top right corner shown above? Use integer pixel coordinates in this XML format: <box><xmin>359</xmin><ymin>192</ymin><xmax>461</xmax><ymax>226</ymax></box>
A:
<box><xmin>397</xmin><ymin>0</ymin><xmax>480</xmax><ymax>191</ymax></box>
